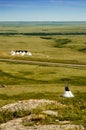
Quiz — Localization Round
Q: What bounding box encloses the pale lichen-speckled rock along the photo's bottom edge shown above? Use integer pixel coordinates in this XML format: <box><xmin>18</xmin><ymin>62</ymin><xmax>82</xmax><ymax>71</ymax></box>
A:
<box><xmin>0</xmin><ymin>117</ymin><xmax>84</xmax><ymax>130</ymax></box>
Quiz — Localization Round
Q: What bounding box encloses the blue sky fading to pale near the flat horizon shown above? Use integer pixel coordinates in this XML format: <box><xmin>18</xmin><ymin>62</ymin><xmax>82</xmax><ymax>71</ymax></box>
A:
<box><xmin>0</xmin><ymin>0</ymin><xmax>86</xmax><ymax>21</ymax></box>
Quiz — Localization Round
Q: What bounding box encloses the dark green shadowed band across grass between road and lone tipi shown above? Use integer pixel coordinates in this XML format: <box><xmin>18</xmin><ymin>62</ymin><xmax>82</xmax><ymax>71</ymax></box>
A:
<box><xmin>0</xmin><ymin>70</ymin><xmax>86</xmax><ymax>86</ymax></box>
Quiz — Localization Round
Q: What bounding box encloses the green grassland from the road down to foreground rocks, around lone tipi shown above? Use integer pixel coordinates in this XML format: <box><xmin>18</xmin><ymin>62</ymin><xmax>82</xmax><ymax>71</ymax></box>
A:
<box><xmin>0</xmin><ymin>62</ymin><xmax>86</xmax><ymax>127</ymax></box>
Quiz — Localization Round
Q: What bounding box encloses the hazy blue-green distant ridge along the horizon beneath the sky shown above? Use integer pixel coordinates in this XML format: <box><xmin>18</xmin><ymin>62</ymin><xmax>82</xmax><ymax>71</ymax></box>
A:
<box><xmin>0</xmin><ymin>21</ymin><xmax>86</xmax><ymax>26</ymax></box>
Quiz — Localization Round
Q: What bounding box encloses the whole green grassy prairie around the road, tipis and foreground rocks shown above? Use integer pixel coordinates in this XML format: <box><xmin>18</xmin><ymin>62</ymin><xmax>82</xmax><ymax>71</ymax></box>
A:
<box><xmin>0</xmin><ymin>21</ymin><xmax>86</xmax><ymax>127</ymax></box>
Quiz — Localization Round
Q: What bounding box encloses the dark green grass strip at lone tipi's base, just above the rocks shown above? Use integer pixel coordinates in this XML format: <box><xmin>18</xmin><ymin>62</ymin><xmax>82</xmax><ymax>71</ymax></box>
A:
<box><xmin>0</xmin><ymin>91</ymin><xmax>86</xmax><ymax>105</ymax></box>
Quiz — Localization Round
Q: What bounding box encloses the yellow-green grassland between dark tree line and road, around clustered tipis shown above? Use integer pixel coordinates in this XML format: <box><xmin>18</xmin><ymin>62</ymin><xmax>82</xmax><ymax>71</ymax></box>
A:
<box><xmin>0</xmin><ymin>36</ymin><xmax>86</xmax><ymax>63</ymax></box>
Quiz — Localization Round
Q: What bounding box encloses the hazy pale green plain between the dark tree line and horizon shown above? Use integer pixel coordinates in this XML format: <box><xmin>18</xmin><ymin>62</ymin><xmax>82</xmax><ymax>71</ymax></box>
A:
<box><xmin>0</xmin><ymin>22</ymin><xmax>86</xmax><ymax>33</ymax></box>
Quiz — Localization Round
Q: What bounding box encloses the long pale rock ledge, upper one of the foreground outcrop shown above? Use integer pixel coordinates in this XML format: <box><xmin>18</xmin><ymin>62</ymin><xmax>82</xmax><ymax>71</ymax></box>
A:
<box><xmin>0</xmin><ymin>99</ymin><xmax>57</xmax><ymax>112</ymax></box>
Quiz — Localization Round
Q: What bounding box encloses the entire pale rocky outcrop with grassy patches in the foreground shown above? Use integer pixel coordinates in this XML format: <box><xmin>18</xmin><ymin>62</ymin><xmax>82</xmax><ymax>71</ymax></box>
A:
<box><xmin>0</xmin><ymin>99</ymin><xmax>84</xmax><ymax>130</ymax></box>
